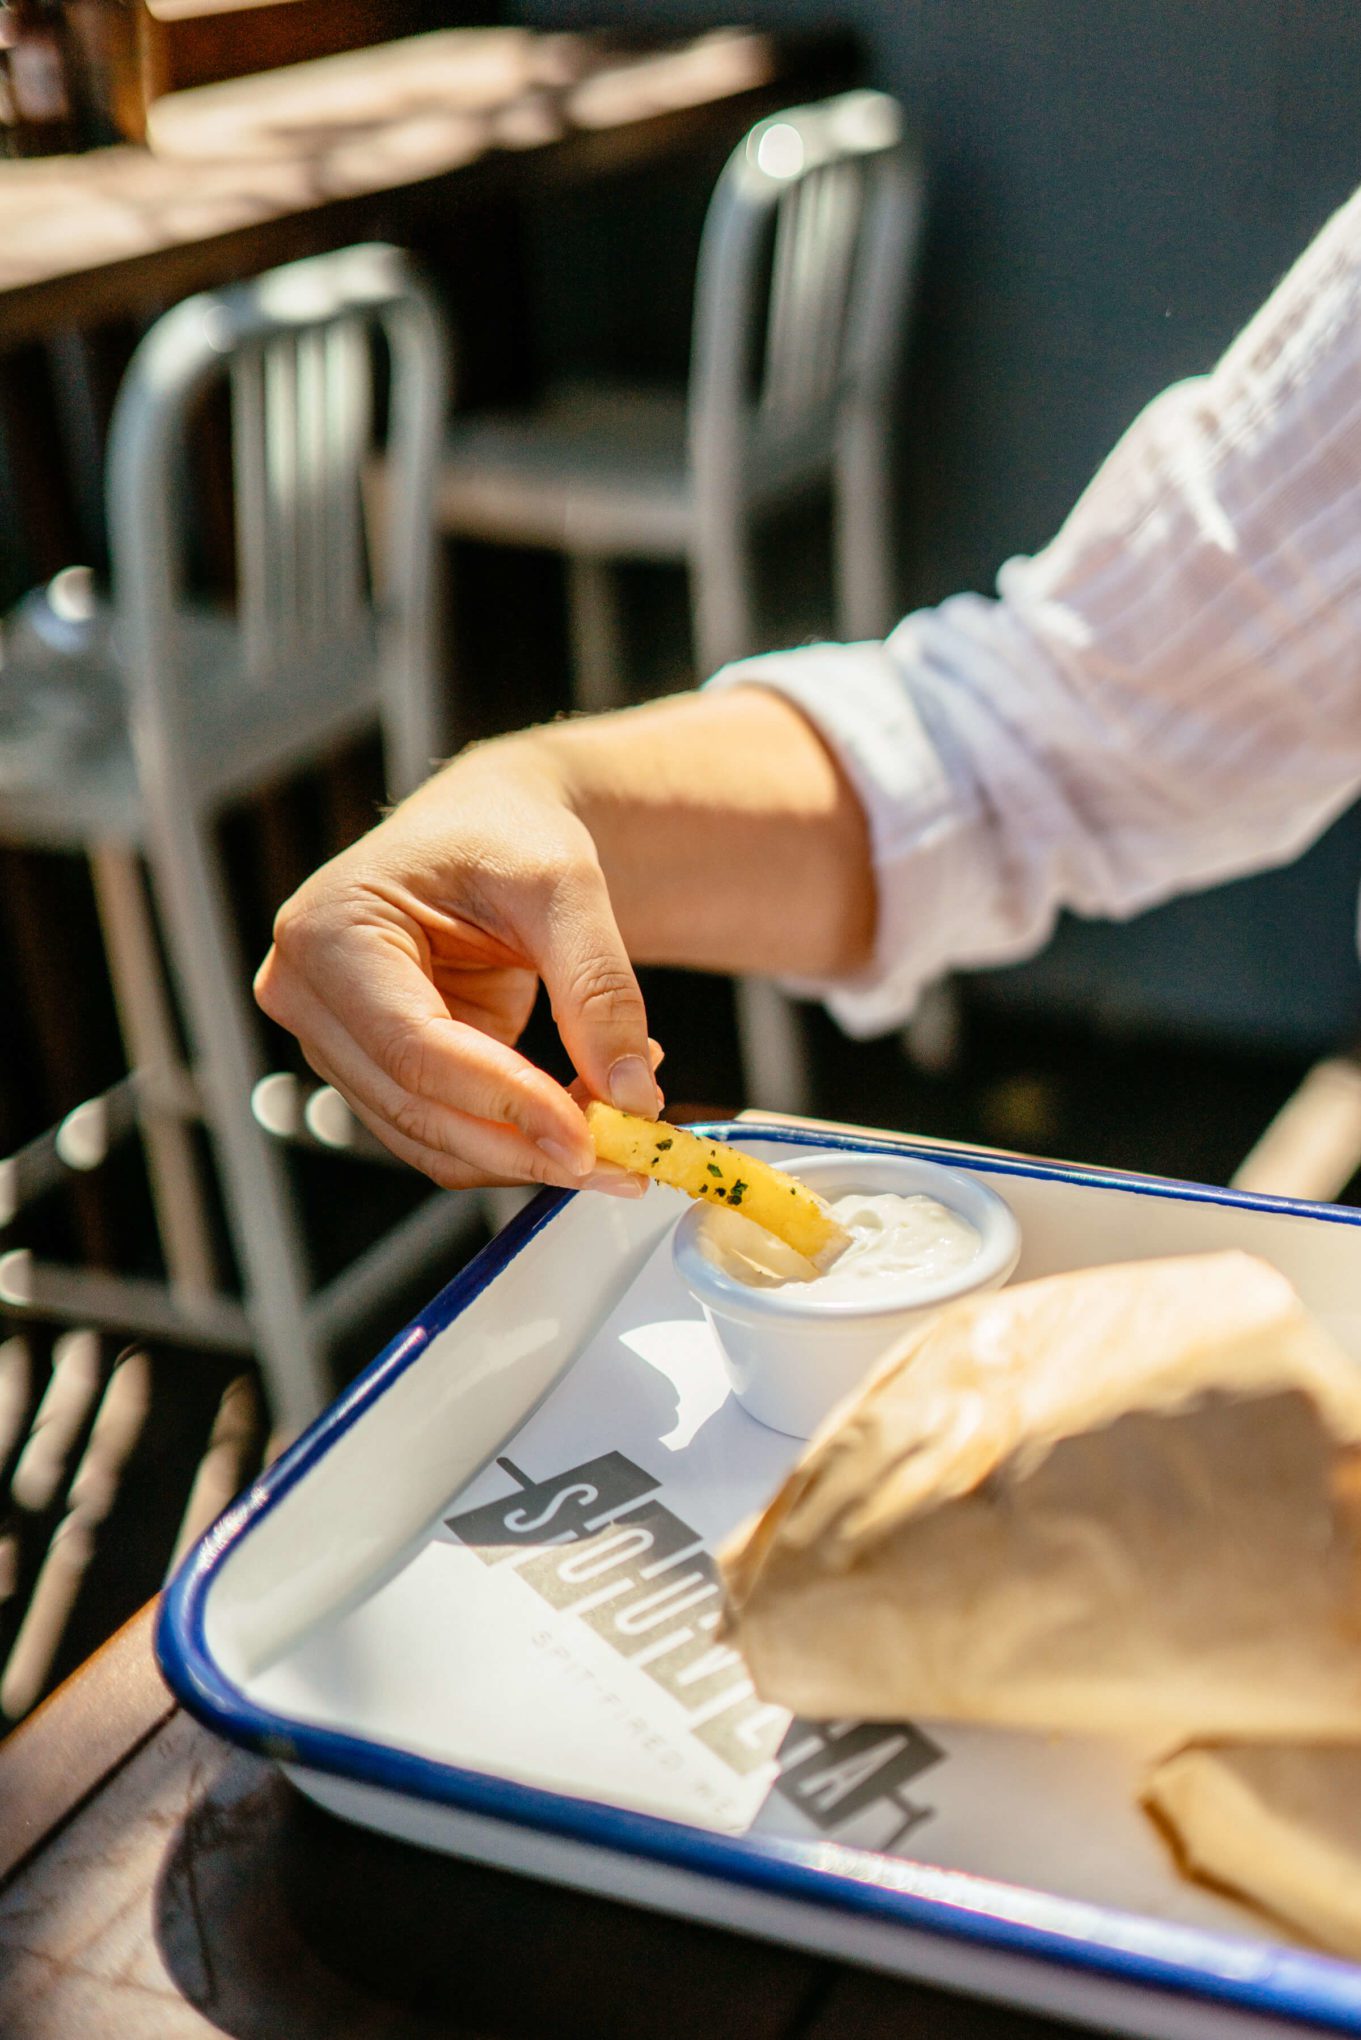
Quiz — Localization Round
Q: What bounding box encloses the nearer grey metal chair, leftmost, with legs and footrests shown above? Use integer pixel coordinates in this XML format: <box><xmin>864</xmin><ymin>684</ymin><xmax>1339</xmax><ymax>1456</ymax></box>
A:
<box><xmin>0</xmin><ymin>245</ymin><xmax>471</xmax><ymax>1432</ymax></box>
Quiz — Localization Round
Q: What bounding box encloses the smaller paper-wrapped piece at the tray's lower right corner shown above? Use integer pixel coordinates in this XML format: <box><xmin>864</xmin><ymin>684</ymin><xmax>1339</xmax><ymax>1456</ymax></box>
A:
<box><xmin>1145</xmin><ymin>1742</ymin><xmax>1361</xmax><ymax>1960</ymax></box>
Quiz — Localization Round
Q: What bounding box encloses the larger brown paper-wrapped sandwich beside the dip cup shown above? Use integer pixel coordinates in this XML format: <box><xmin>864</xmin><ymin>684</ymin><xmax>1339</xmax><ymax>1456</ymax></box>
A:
<box><xmin>722</xmin><ymin>1253</ymin><xmax>1361</xmax><ymax>1748</ymax></box>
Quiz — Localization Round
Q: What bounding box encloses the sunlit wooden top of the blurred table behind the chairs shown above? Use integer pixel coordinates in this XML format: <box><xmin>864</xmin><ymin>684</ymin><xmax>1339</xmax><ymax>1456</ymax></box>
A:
<box><xmin>0</xmin><ymin>29</ymin><xmax>849</xmax><ymax>347</ymax></box>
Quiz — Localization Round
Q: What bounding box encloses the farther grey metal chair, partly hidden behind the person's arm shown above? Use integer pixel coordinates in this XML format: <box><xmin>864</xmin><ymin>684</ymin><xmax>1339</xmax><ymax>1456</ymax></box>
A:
<box><xmin>439</xmin><ymin>92</ymin><xmax>922</xmax><ymax>1110</ymax></box>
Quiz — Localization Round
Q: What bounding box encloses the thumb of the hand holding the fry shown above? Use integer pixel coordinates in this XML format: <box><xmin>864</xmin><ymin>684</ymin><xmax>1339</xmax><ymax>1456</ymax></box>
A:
<box><xmin>537</xmin><ymin>869</ymin><xmax>661</xmax><ymax>1120</ymax></box>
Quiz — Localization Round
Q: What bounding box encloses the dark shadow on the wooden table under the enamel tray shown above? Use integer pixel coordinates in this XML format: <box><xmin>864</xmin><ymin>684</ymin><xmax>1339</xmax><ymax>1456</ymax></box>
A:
<box><xmin>155</xmin><ymin>1754</ymin><xmax>826</xmax><ymax>2040</ymax></box>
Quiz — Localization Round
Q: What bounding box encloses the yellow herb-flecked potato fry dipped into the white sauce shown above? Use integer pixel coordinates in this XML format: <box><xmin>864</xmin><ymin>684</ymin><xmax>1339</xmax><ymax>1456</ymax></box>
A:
<box><xmin>586</xmin><ymin>1104</ymin><xmax>849</xmax><ymax>1261</ymax></box>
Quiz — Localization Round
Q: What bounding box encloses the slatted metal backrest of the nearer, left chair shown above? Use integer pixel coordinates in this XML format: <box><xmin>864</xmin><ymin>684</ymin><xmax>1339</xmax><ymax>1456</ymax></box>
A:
<box><xmin>108</xmin><ymin>245</ymin><xmax>449</xmax><ymax>798</ymax></box>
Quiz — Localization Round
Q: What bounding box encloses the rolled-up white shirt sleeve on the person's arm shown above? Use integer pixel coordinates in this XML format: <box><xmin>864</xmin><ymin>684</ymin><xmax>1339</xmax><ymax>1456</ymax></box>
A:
<box><xmin>710</xmin><ymin>177</ymin><xmax>1361</xmax><ymax>1034</ymax></box>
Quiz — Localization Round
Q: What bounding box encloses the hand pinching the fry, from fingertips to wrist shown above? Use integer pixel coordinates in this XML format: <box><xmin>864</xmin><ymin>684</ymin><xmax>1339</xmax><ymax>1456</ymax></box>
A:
<box><xmin>255</xmin><ymin>738</ymin><xmax>661</xmax><ymax>1193</ymax></box>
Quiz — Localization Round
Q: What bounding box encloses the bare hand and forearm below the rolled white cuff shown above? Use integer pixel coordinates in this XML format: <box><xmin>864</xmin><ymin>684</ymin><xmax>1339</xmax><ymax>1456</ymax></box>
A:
<box><xmin>255</xmin><ymin>687</ymin><xmax>875</xmax><ymax>1193</ymax></box>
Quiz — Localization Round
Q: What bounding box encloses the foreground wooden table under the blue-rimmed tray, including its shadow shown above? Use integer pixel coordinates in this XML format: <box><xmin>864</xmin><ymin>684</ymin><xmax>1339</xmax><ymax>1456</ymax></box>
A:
<box><xmin>0</xmin><ymin>1610</ymin><xmax>1071</xmax><ymax>2040</ymax></box>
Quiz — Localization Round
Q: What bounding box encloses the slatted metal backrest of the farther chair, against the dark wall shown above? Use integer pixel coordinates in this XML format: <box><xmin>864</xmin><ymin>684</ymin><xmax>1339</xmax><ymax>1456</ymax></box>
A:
<box><xmin>690</xmin><ymin>92</ymin><xmax>922</xmax><ymax>612</ymax></box>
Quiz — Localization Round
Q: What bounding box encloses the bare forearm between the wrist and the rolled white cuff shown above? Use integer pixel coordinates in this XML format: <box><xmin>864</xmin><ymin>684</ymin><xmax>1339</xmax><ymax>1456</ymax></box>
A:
<box><xmin>452</xmin><ymin>687</ymin><xmax>875</xmax><ymax>979</ymax></box>
